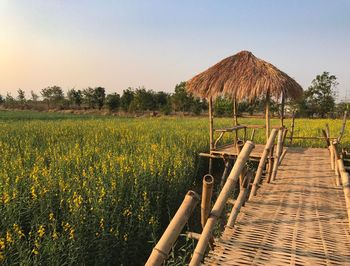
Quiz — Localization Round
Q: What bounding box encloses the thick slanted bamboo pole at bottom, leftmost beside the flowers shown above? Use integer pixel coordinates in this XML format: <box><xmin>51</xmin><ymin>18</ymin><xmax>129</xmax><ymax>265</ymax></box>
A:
<box><xmin>146</xmin><ymin>190</ymin><xmax>200</xmax><ymax>266</ymax></box>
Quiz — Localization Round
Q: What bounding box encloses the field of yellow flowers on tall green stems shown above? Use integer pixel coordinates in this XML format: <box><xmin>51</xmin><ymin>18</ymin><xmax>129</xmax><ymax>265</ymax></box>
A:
<box><xmin>0</xmin><ymin>111</ymin><xmax>349</xmax><ymax>265</ymax></box>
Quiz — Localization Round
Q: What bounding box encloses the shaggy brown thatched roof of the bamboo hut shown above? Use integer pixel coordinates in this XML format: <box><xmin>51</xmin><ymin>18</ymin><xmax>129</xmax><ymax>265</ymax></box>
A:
<box><xmin>186</xmin><ymin>51</ymin><xmax>303</xmax><ymax>100</ymax></box>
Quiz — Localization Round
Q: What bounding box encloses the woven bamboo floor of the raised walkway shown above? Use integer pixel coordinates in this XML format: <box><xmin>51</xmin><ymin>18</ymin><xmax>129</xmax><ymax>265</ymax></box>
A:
<box><xmin>204</xmin><ymin>148</ymin><xmax>350</xmax><ymax>265</ymax></box>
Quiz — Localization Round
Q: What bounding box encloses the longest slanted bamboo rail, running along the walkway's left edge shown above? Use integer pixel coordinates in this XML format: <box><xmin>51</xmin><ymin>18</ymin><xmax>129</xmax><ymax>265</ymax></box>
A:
<box><xmin>190</xmin><ymin>141</ymin><xmax>254</xmax><ymax>266</ymax></box>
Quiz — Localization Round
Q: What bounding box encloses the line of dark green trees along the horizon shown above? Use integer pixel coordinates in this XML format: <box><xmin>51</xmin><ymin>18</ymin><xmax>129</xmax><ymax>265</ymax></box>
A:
<box><xmin>0</xmin><ymin>72</ymin><xmax>349</xmax><ymax>117</ymax></box>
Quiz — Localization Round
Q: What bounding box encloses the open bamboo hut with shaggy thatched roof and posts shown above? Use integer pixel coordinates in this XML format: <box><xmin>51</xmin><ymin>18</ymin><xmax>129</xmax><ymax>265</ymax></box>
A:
<box><xmin>186</xmin><ymin>51</ymin><xmax>303</xmax><ymax>172</ymax></box>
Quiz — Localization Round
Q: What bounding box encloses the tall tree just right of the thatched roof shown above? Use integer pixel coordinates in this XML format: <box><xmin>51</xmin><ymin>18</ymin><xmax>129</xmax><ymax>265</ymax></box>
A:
<box><xmin>304</xmin><ymin>71</ymin><xmax>338</xmax><ymax>117</ymax></box>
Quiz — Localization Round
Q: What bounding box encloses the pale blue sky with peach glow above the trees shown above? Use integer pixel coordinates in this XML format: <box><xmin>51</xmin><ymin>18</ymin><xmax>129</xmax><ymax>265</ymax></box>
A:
<box><xmin>0</xmin><ymin>0</ymin><xmax>350</xmax><ymax>100</ymax></box>
